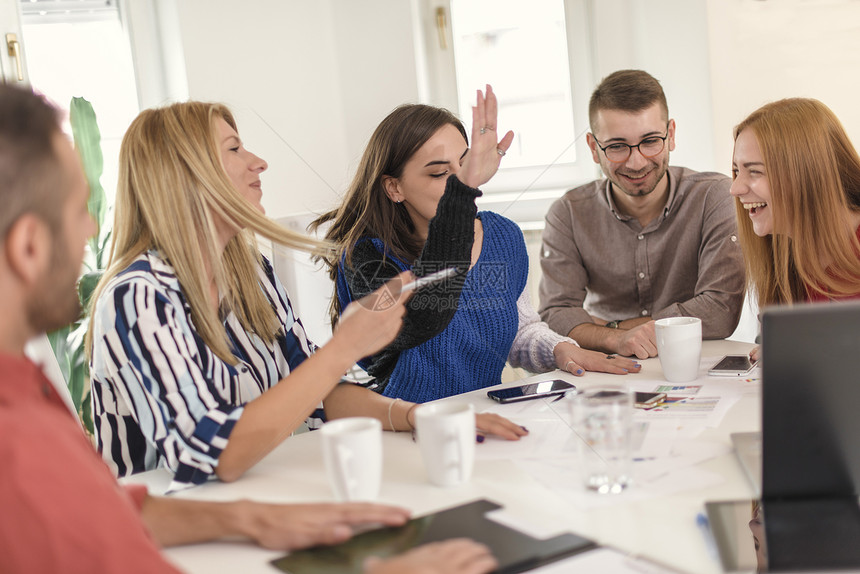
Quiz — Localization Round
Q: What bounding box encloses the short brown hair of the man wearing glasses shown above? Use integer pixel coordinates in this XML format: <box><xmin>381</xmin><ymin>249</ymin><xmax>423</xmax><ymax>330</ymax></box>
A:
<box><xmin>588</xmin><ymin>70</ymin><xmax>669</xmax><ymax>131</ymax></box>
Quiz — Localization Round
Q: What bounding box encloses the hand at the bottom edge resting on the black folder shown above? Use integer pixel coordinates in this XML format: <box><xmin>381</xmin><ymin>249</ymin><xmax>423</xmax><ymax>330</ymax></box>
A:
<box><xmin>364</xmin><ymin>538</ymin><xmax>498</xmax><ymax>574</ymax></box>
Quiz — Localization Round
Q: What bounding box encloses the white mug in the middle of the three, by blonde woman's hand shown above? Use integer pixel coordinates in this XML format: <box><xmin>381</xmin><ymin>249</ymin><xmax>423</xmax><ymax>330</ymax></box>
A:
<box><xmin>415</xmin><ymin>403</ymin><xmax>476</xmax><ymax>486</ymax></box>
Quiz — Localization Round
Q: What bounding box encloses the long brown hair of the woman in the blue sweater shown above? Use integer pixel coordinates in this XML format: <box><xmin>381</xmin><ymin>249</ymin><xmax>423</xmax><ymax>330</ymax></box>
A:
<box><xmin>308</xmin><ymin>104</ymin><xmax>469</xmax><ymax>324</ymax></box>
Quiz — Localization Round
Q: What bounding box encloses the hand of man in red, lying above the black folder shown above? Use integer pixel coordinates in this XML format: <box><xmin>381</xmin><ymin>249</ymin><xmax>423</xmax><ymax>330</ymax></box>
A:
<box><xmin>236</xmin><ymin>501</ymin><xmax>409</xmax><ymax>550</ymax></box>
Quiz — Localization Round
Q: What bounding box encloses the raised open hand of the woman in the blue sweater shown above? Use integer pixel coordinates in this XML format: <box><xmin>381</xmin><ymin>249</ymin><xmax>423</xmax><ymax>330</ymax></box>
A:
<box><xmin>458</xmin><ymin>84</ymin><xmax>514</xmax><ymax>187</ymax></box>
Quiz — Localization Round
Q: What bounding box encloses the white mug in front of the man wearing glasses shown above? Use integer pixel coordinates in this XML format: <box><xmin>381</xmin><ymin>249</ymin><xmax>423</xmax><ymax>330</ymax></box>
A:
<box><xmin>654</xmin><ymin>317</ymin><xmax>702</xmax><ymax>383</ymax></box>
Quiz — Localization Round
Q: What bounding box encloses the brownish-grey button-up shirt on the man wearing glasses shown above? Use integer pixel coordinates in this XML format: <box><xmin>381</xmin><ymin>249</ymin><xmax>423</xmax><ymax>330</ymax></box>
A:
<box><xmin>540</xmin><ymin>167</ymin><xmax>744</xmax><ymax>339</ymax></box>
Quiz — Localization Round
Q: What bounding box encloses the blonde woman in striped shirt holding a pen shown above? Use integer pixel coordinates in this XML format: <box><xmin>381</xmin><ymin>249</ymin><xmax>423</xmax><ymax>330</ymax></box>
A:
<box><xmin>88</xmin><ymin>102</ymin><xmax>524</xmax><ymax>488</ymax></box>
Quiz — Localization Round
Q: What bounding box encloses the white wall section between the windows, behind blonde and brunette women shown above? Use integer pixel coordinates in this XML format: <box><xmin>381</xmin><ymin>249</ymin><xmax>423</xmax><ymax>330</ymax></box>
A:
<box><xmin>170</xmin><ymin>0</ymin><xmax>418</xmax><ymax>218</ymax></box>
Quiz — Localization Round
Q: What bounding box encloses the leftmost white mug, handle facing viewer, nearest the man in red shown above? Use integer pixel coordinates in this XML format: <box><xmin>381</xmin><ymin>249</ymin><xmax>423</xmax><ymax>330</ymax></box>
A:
<box><xmin>318</xmin><ymin>417</ymin><xmax>382</xmax><ymax>502</ymax></box>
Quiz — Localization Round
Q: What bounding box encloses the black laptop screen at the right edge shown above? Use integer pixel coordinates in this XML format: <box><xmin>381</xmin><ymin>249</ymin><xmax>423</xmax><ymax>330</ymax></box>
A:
<box><xmin>761</xmin><ymin>302</ymin><xmax>860</xmax><ymax>500</ymax></box>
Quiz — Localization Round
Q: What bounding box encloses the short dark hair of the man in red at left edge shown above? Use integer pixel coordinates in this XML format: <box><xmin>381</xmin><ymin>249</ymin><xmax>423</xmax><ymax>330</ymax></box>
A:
<box><xmin>0</xmin><ymin>84</ymin><xmax>62</xmax><ymax>241</ymax></box>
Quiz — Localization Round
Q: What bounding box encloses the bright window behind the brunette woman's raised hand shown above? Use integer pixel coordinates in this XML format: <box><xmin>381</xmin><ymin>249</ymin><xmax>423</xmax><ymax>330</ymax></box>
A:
<box><xmin>422</xmin><ymin>0</ymin><xmax>596</xmax><ymax>207</ymax></box>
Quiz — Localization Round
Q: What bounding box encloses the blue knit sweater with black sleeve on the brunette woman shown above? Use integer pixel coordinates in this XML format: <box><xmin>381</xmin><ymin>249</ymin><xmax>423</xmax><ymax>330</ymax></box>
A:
<box><xmin>337</xmin><ymin>207</ymin><xmax>528</xmax><ymax>402</ymax></box>
